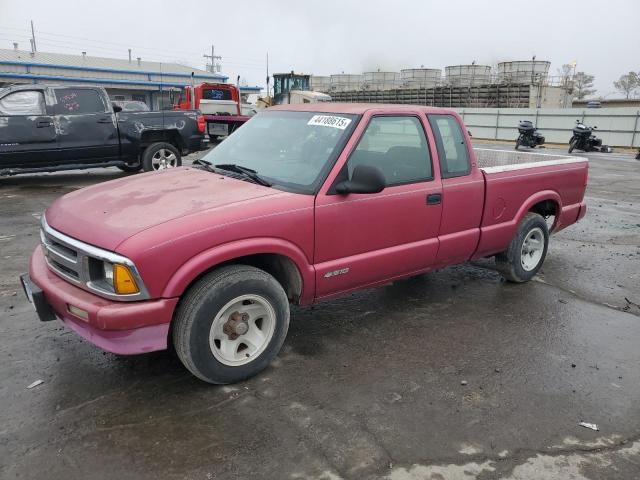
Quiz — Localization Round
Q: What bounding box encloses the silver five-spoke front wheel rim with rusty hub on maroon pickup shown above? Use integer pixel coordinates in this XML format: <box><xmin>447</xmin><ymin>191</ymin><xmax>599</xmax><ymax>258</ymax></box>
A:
<box><xmin>209</xmin><ymin>295</ymin><xmax>276</xmax><ymax>367</ymax></box>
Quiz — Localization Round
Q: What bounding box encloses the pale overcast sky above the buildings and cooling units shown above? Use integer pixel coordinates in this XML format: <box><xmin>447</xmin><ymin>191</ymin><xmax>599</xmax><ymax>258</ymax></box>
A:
<box><xmin>0</xmin><ymin>0</ymin><xmax>640</xmax><ymax>97</ymax></box>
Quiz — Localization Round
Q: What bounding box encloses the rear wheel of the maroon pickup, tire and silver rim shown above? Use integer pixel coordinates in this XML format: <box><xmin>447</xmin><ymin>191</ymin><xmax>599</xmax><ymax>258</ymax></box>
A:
<box><xmin>496</xmin><ymin>212</ymin><xmax>549</xmax><ymax>283</ymax></box>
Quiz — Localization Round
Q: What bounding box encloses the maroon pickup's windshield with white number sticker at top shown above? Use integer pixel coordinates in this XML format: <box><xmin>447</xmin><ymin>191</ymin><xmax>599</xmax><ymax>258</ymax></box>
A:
<box><xmin>204</xmin><ymin>111</ymin><xmax>357</xmax><ymax>194</ymax></box>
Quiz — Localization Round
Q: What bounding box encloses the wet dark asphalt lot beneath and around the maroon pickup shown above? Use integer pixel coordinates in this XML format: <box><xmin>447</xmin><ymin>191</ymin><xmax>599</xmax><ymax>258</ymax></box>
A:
<box><xmin>0</xmin><ymin>146</ymin><xmax>640</xmax><ymax>480</ymax></box>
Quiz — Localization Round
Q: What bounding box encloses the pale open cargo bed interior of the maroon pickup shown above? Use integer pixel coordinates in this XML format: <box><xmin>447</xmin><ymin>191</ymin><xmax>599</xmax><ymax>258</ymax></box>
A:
<box><xmin>474</xmin><ymin>148</ymin><xmax>588</xmax><ymax>174</ymax></box>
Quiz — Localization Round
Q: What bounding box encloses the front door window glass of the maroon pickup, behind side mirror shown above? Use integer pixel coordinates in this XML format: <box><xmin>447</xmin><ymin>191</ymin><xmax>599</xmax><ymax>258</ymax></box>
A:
<box><xmin>347</xmin><ymin>116</ymin><xmax>433</xmax><ymax>186</ymax></box>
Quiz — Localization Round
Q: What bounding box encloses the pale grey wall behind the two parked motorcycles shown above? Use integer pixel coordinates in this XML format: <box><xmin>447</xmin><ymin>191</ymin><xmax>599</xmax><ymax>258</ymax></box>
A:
<box><xmin>453</xmin><ymin>108</ymin><xmax>640</xmax><ymax>147</ymax></box>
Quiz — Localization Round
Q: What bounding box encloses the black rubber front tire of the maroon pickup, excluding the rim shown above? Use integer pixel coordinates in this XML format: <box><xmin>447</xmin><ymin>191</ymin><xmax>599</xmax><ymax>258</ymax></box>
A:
<box><xmin>172</xmin><ymin>265</ymin><xmax>289</xmax><ymax>384</ymax></box>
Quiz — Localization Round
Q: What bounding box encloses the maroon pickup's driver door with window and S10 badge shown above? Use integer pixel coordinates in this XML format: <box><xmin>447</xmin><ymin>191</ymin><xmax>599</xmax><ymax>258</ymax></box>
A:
<box><xmin>314</xmin><ymin>114</ymin><xmax>442</xmax><ymax>299</ymax></box>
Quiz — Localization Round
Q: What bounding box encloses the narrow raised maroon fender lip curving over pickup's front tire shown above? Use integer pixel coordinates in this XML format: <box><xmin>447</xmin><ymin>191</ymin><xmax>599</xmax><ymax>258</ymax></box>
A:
<box><xmin>162</xmin><ymin>237</ymin><xmax>316</xmax><ymax>304</ymax></box>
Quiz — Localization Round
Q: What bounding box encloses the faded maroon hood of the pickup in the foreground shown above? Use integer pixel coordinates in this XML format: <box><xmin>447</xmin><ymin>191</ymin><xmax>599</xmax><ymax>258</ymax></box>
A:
<box><xmin>45</xmin><ymin>168</ymin><xmax>283</xmax><ymax>251</ymax></box>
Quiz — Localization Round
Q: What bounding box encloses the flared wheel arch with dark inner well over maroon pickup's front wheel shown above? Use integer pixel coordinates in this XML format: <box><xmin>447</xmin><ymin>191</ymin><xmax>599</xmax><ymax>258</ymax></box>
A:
<box><xmin>162</xmin><ymin>238</ymin><xmax>315</xmax><ymax>304</ymax></box>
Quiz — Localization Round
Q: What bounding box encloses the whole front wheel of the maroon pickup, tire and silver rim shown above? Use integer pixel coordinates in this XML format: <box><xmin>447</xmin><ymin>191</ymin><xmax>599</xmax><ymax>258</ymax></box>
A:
<box><xmin>173</xmin><ymin>265</ymin><xmax>289</xmax><ymax>384</ymax></box>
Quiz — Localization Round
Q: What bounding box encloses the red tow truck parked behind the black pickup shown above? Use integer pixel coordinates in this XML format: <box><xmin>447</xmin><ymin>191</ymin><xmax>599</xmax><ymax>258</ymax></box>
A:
<box><xmin>173</xmin><ymin>83</ymin><xmax>251</xmax><ymax>140</ymax></box>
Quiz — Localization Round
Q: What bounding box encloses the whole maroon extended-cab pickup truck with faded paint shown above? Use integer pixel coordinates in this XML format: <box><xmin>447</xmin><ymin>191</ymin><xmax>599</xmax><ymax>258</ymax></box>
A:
<box><xmin>22</xmin><ymin>104</ymin><xmax>588</xmax><ymax>383</ymax></box>
